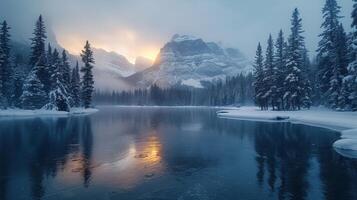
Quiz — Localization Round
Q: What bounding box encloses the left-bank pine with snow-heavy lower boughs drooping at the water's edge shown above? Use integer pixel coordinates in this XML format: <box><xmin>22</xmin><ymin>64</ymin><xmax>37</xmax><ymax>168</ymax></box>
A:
<box><xmin>44</xmin><ymin>49</ymin><xmax>70</xmax><ymax>112</ymax></box>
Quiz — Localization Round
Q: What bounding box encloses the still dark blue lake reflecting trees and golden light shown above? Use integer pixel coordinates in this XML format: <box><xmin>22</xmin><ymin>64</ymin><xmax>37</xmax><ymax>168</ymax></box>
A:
<box><xmin>0</xmin><ymin>107</ymin><xmax>357</xmax><ymax>200</ymax></box>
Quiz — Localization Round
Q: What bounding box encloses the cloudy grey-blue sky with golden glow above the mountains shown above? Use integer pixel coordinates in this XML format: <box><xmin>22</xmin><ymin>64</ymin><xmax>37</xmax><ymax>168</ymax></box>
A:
<box><xmin>0</xmin><ymin>0</ymin><xmax>353</xmax><ymax>62</ymax></box>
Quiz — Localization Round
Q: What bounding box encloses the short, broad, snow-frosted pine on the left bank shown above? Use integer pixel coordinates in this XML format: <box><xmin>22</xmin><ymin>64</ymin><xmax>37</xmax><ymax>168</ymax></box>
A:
<box><xmin>20</xmin><ymin>56</ymin><xmax>47</xmax><ymax>110</ymax></box>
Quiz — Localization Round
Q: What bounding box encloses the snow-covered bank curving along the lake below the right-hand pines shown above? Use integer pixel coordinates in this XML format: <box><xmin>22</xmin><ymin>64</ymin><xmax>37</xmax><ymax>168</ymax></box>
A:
<box><xmin>217</xmin><ymin>107</ymin><xmax>357</xmax><ymax>158</ymax></box>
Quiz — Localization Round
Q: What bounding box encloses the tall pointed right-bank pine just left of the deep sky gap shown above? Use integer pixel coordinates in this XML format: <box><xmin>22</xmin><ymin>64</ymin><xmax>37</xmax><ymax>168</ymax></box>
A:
<box><xmin>284</xmin><ymin>8</ymin><xmax>309</xmax><ymax>110</ymax></box>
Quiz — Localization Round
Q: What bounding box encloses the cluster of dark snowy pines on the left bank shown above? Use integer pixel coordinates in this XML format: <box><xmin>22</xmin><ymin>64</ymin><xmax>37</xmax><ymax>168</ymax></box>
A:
<box><xmin>0</xmin><ymin>16</ymin><xmax>94</xmax><ymax>111</ymax></box>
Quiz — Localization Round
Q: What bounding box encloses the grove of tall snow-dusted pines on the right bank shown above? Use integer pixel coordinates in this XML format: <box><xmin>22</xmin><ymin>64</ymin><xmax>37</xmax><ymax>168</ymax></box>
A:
<box><xmin>254</xmin><ymin>0</ymin><xmax>357</xmax><ymax>111</ymax></box>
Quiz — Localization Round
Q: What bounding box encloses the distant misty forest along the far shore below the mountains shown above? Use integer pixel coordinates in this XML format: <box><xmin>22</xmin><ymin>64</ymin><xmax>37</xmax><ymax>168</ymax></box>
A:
<box><xmin>94</xmin><ymin>73</ymin><xmax>254</xmax><ymax>106</ymax></box>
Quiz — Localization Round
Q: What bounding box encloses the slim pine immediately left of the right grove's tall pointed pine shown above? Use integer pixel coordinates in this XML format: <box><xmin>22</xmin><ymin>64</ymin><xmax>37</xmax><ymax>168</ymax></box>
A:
<box><xmin>274</xmin><ymin>30</ymin><xmax>286</xmax><ymax>110</ymax></box>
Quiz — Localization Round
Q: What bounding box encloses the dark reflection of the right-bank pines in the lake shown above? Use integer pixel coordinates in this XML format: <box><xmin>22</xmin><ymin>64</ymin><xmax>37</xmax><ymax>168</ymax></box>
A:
<box><xmin>254</xmin><ymin>123</ymin><xmax>357</xmax><ymax>199</ymax></box>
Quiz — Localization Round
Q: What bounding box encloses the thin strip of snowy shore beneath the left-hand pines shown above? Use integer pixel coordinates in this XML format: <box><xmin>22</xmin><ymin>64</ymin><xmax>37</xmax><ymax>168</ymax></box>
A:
<box><xmin>0</xmin><ymin>108</ymin><xmax>98</xmax><ymax>117</ymax></box>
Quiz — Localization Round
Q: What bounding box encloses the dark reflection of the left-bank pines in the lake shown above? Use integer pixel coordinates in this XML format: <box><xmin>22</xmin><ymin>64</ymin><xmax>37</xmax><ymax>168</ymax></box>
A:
<box><xmin>0</xmin><ymin>117</ymin><xmax>92</xmax><ymax>199</ymax></box>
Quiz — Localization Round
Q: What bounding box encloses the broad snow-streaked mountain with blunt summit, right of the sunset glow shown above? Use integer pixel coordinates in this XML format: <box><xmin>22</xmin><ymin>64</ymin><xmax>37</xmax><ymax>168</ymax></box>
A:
<box><xmin>128</xmin><ymin>35</ymin><xmax>251</xmax><ymax>88</ymax></box>
